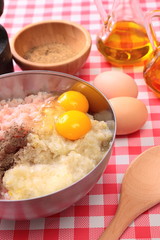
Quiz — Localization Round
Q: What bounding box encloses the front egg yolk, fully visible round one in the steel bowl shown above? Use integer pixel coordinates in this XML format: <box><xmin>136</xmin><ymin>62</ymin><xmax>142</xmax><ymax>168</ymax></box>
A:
<box><xmin>55</xmin><ymin>110</ymin><xmax>91</xmax><ymax>140</ymax></box>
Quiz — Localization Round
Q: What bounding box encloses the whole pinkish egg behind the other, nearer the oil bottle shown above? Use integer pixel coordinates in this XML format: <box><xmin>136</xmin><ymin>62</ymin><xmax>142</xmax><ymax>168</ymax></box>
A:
<box><xmin>93</xmin><ymin>71</ymin><xmax>138</xmax><ymax>99</ymax></box>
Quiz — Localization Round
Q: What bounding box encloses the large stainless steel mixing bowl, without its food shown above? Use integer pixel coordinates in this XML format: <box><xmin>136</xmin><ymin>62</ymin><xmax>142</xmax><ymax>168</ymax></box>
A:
<box><xmin>0</xmin><ymin>70</ymin><xmax>116</xmax><ymax>220</ymax></box>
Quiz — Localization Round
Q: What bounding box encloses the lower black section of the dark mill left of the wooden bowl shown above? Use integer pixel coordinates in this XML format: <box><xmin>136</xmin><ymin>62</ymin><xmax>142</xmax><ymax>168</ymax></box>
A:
<box><xmin>0</xmin><ymin>25</ymin><xmax>14</xmax><ymax>74</ymax></box>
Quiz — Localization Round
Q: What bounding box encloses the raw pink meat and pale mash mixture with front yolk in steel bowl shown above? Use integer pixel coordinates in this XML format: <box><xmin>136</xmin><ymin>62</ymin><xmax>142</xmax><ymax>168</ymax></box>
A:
<box><xmin>0</xmin><ymin>92</ymin><xmax>113</xmax><ymax>200</ymax></box>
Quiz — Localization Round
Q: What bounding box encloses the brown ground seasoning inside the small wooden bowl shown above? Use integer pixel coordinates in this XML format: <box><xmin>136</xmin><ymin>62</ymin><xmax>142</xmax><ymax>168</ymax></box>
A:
<box><xmin>24</xmin><ymin>42</ymin><xmax>76</xmax><ymax>64</ymax></box>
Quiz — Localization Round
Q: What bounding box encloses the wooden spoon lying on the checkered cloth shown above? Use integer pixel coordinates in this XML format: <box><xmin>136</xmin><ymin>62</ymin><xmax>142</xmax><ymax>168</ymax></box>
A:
<box><xmin>99</xmin><ymin>146</ymin><xmax>160</xmax><ymax>240</ymax></box>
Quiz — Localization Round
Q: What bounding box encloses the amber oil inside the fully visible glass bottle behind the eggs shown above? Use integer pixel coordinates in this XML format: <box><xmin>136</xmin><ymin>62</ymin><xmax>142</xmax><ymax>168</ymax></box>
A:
<box><xmin>97</xmin><ymin>21</ymin><xmax>152</xmax><ymax>66</ymax></box>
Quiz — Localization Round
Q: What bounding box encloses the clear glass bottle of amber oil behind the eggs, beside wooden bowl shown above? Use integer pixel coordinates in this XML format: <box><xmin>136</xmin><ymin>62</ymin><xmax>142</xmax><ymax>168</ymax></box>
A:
<box><xmin>95</xmin><ymin>0</ymin><xmax>159</xmax><ymax>66</ymax></box>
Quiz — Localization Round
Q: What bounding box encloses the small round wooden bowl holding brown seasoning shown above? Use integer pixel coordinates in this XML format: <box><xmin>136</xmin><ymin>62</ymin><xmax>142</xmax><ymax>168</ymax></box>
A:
<box><xmin>11</xmin><ymin>20</ymin><xmax>92</xmax><ymax>74</ymax></box>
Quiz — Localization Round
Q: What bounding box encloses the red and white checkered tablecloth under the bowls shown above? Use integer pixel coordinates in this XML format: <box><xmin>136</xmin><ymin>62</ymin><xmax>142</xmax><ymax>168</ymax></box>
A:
<box><xmin>0</xmin><ymin>0</ymin><xmax>160</xmax><ymax>240</ymax></box>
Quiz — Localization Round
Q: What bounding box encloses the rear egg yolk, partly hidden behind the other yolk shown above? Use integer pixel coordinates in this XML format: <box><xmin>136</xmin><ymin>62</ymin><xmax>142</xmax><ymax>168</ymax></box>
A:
<box><xmin>58</xmin><ymin>91</ymin><xmax>89</xmax><ymax>113</ymax></box>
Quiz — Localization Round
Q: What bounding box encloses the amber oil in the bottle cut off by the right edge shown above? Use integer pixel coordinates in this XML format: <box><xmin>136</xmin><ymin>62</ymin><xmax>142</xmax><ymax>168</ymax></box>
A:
<box><xmin>143</xmin><ymin>50</ymin><xmax>160</xmax><ymax>98</ymax></box>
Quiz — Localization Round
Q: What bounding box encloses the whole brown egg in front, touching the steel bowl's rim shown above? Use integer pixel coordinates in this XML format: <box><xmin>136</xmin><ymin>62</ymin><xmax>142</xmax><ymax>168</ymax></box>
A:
<box><xmin>109</xmin><ymin>97</ymin><xmax>148</xmax><ymax>135</ymax></box>
